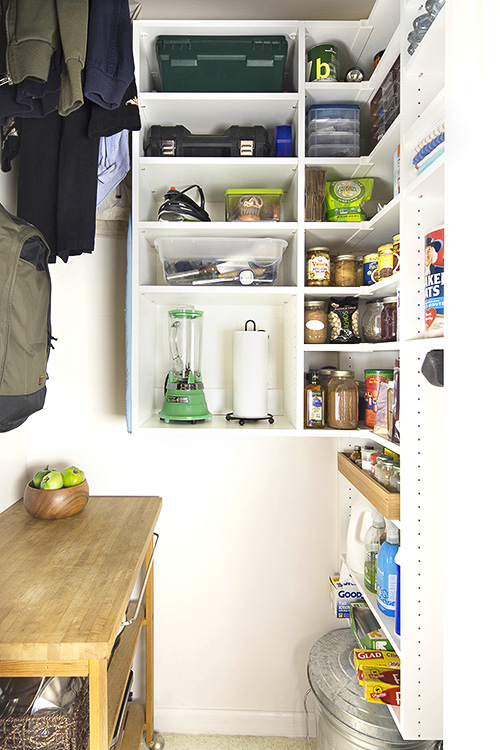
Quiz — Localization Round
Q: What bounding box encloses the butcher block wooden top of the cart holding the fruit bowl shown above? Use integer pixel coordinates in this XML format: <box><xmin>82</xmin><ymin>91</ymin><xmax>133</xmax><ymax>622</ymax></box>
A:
<box><xmin>0</xmin><ymin>497</ymin><xmax>161</xmax><ymax>661</ymax></box>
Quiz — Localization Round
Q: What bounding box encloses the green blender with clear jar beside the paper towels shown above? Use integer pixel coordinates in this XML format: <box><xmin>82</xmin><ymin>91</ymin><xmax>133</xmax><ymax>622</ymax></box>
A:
<box><xmin>159</xmin><ymin>305</ymin><xmax>212</xmax><ymax>422</ymax></box>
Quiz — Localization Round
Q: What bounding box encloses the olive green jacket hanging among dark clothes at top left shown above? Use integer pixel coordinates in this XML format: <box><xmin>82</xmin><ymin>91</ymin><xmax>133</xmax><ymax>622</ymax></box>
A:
<box><xmin>4</xmin><ymin>0</ymin><xmax>89</xmax><ymax>115</ymax></box>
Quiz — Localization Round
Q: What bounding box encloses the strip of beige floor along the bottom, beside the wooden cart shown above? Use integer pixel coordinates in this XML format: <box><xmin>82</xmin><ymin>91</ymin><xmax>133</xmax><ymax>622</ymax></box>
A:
<box><xmin>142</xmin><ymin>734</ymin><xmax>316</xmax><ymax>750</ymax></box>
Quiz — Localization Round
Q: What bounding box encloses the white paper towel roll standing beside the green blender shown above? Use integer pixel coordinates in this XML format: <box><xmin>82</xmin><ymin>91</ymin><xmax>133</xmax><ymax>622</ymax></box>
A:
<box><xmin>233</xmin><ymin>331</ymin><xmax>269</xmax><ymax>419</ymax></box>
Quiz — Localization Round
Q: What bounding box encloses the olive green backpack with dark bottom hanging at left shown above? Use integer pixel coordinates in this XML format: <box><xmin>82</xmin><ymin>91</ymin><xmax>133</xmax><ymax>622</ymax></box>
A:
<box><xmin>0</xmin><ymin>204</ymin><xmax>52</xmax><ymax>432</ymax></box>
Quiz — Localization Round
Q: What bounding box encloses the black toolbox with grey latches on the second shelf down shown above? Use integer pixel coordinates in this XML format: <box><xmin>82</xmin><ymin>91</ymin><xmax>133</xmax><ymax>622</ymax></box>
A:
<box><xmin>144</xmin><ymin>125</ymin><xmax>271</xmax><ymax>156</ymax></box>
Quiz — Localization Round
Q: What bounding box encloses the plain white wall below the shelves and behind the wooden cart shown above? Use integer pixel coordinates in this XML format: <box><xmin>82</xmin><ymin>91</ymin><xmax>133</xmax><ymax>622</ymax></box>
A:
<box><xmin>17</xmin><ymin>239</ymin><xmax>337</xmax><ymax>735</ymax></box>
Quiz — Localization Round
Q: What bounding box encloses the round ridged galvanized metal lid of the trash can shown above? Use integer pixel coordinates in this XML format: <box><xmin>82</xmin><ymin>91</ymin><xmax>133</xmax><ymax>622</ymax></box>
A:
<box><xmin>307</xmin><ymin>629</ymin><xmax>410</xmax><ymax>748</ymax></box>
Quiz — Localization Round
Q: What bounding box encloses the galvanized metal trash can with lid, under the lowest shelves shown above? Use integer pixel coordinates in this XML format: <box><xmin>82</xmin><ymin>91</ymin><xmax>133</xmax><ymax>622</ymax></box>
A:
<box><xmin>307</xmin><ymin>629</ymin><xmax>440</xmax><ymax>750</ymax></box>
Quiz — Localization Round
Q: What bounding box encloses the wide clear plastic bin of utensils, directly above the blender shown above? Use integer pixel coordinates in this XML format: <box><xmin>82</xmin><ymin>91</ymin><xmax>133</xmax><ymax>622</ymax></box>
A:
<box><xmin>154</xmin><ymin>237</ymin><xmax>288</xmax><ymax>286</ymax></box>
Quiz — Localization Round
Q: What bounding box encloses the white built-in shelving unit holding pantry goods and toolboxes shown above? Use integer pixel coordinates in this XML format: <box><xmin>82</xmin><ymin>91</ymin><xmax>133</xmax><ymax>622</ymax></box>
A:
<box><xmin>131</xmin><ymin>0</ymin><xmax>445</xmax><ymax>739</ymax></box>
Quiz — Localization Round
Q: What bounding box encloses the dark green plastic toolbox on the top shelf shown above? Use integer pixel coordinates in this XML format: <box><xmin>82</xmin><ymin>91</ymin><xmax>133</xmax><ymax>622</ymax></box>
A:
<box><xmin>156</xmin><ymin>36</ymin><xmax>288</xmax><ymax>92</ymax></box>
